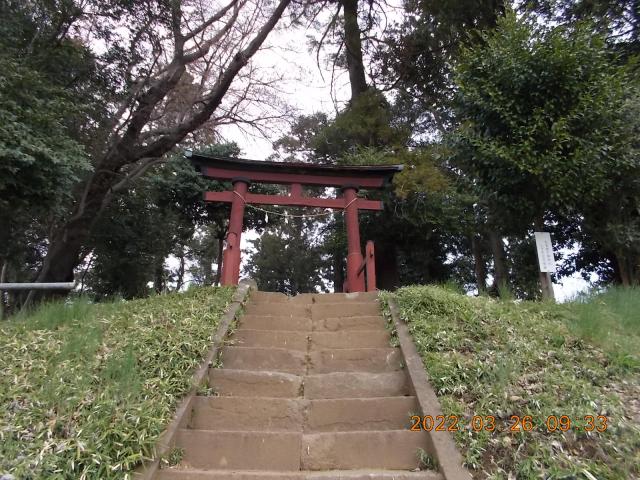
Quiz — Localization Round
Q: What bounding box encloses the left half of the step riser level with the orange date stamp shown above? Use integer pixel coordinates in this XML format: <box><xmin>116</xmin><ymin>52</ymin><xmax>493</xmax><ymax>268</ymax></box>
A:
<box><xmin>189</xmin><ymin>396</ymin><xmax>304</xmax><ymax>432</ymax></box>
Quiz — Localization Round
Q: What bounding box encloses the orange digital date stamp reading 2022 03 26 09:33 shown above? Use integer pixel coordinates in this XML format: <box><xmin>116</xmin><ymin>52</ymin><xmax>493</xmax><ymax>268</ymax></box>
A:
<box><xmin>409</xmin><ymin>415</ymin><xmax>609</xmax><ymax>433</ymax></box>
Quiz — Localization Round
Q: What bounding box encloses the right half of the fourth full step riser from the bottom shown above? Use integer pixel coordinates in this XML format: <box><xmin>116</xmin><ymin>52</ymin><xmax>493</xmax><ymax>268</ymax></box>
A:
<box><xmin>309</xmin><ymin>347</ymin><xmax>402</xmax><ymax>374</ymax></box>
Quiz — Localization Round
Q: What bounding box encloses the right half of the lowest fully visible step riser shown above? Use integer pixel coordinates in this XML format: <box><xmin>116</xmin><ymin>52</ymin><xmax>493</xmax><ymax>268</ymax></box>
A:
<box><xmin>301</xmin><ymin>430</ymin><xmax>428</xmax><ymax>470</ymax></box>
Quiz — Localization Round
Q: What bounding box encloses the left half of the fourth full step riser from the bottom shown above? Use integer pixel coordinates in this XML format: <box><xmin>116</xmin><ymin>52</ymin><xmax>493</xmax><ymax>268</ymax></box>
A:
<box><xmin>222</xmin><ymin>347</ymin><xmax>307</xmax><ymax>375</ymax></box>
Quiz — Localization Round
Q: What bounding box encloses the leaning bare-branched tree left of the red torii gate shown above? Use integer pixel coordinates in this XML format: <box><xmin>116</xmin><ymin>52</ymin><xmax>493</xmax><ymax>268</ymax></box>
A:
<box><xmin>13</xmin><ymin>0</ymin><xmax>290</xmax><ymax>296</ymax></box>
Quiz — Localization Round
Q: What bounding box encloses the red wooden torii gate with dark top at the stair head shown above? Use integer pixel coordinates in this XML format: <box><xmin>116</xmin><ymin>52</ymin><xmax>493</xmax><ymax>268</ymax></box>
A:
<box><xmin>187</xmin><ymin>153</ymin><xmax>402</xmax><ymax>292</ymax></box>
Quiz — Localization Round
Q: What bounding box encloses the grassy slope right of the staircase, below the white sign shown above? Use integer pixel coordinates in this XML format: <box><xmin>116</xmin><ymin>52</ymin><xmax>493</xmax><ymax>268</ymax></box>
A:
<box><xmin>385</xmin><ymin>287</ymin><xmax>640</xmax><ymax>480</ymax></box>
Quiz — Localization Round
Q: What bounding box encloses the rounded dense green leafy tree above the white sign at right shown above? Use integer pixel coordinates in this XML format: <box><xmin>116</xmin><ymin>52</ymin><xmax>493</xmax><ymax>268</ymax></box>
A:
<box><xmin>451</xmin><ymin>14</ymin><xmax>638</xmax><ymax>290</ymax></box>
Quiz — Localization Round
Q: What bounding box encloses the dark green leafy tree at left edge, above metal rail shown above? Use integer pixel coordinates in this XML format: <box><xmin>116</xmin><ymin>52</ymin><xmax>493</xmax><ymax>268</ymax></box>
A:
<box><xmin>0</xmin><ymin>2</ymin><xmax>99</xmax><ymax>296</ymax></box>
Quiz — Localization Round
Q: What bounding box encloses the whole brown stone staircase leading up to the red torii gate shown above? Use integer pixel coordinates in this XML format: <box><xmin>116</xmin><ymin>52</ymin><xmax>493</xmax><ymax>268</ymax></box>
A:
<box><xmin>155</xmin><ymin>292</ymin><xmax>443</xmax><ymax>480</ymax></box>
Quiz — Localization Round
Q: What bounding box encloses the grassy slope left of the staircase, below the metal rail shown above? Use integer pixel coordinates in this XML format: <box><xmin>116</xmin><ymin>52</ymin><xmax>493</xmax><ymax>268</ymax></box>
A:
<box><xmin>0</xmin><ymin>288</ymin><xmax>233</xmax><ymax>479</ymax></box>
